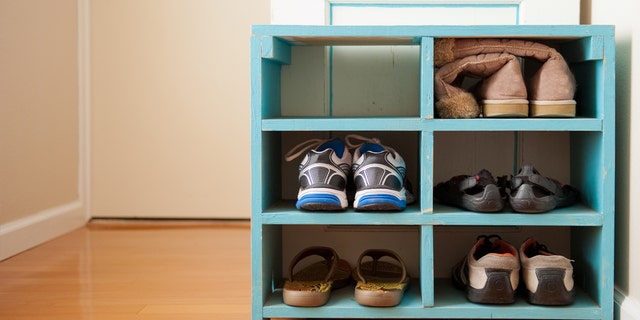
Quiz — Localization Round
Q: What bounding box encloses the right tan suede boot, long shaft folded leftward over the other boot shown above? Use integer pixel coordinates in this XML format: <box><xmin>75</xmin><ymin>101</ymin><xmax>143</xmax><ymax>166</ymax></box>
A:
<box><xmin>434</xmin><ymin>38</ymin><xmax>576</xmax><ymax>117</ymax></box>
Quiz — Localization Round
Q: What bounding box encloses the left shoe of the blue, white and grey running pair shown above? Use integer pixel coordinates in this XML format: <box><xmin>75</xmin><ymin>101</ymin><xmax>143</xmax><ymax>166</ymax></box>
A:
<box><xmin>285</xmin><ymin>138</ymin><xmax>351</xmax><ymax>211</ymax></box>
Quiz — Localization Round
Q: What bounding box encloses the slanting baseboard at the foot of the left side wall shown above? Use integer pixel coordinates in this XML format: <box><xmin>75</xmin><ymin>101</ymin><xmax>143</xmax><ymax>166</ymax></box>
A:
<box><xmin>0</xmin><ymin>201</ymin><xmax>87</xmax><ymax>261</ymax></box>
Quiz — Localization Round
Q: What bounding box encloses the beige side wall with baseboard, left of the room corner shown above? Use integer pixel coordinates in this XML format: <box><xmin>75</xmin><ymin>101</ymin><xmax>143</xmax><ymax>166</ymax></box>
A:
<box><xmin>0</xmin><ymin>0</ymin><xmax>85</xmax><ymax>260</ymax></box>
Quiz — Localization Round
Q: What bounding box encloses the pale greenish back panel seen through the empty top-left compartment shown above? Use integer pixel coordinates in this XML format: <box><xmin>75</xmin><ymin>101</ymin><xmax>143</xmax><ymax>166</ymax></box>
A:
<box><xmin>280</xmin><ymin>45</ymin><xmax>420</xmax><ymax>118</ymax></box>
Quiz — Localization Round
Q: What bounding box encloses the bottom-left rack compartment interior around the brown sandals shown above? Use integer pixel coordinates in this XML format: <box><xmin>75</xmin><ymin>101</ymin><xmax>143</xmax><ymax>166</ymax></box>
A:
<box><xmin>264</xmin><ymin>224</ymin><xmax>428</xmax><ymax>318</ymax></box>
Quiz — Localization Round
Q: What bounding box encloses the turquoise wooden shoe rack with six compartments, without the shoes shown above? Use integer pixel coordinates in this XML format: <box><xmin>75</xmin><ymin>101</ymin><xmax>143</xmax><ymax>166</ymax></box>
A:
<box><xmin>251</xmin><ymin>25</ymin><xmax>615</xmax><ymax>319</ymax></box>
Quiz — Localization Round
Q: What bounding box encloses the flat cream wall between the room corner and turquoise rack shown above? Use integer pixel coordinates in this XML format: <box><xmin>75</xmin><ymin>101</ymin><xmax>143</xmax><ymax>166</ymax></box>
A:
<box><xmin>90</xmin><ymin>0</ymin><xmax>269</xmax><ymax>218</ymax></box>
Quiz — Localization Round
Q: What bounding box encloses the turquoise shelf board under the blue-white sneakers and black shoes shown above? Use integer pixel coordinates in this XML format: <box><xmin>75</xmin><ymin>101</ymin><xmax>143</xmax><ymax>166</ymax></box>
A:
<box><xmin>260</xmin><ymin>200</ymin><xmax>604</xmax><ymax>226</ymax></box>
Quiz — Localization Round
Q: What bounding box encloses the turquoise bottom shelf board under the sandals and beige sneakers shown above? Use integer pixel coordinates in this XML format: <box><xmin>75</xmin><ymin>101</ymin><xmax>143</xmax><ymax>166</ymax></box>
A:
<box><xmin>263</xmin><ymin>279</ymin><xmax>604</xmax><ymax>319</ymax></box>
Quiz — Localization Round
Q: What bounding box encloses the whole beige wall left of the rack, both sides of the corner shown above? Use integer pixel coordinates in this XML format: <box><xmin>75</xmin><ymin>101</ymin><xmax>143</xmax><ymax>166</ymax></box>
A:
<box><xmin>0</xmin><ymin>0</ymin><xmax>269</xmax><ymax>260</ymax></box>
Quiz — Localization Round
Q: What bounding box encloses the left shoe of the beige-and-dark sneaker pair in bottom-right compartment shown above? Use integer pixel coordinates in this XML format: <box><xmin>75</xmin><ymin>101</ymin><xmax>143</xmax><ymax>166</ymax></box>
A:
<box><xmin>452</xmin><ymin>235</ymin><xmax>520</xmax><ymax>304</ymax></box>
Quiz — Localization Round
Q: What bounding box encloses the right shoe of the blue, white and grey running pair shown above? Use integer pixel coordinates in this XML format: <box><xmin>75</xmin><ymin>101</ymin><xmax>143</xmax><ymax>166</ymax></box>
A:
<box><xmin>346</xmin><ymin>135</ymin><xmax>414</xmax><ymax>211</ymax></box>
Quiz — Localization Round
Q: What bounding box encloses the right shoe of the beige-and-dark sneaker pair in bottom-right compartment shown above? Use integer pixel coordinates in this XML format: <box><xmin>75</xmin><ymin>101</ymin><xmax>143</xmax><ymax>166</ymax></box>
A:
<box><xmin>520</xmin><ymin>238</ymin><xmax>575</xmax><ymax>306</ymax></box>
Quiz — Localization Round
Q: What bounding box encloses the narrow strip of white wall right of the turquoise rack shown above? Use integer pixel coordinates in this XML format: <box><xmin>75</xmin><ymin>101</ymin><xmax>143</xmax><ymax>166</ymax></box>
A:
<box><xmin>581</xmin><ymin>0</ymin><xmax>640</xmax><ymax>320</ymax></box>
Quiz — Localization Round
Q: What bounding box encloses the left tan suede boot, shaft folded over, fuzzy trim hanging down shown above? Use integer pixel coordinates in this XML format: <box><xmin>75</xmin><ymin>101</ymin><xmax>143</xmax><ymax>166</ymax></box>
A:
<box><xmin>434</xmin><ymin>53</ymin><xmax>529</xmax><ymax>118</ymax></box>
